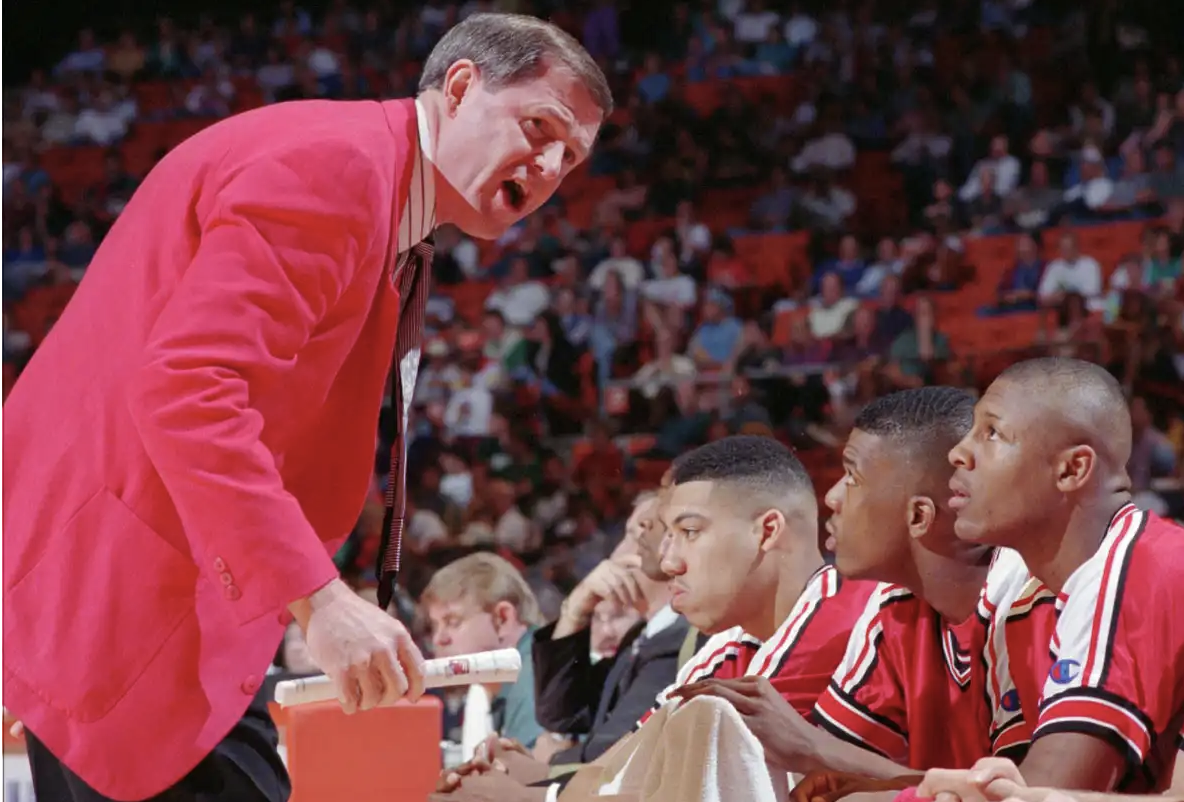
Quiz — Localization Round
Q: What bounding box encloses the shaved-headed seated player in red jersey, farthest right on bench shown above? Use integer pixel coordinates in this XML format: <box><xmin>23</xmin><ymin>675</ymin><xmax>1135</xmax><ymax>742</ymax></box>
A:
<box><xmin>938</xmin><ymin>359</ymin><xmax>1184</xmax><ymax>798</ymax></box>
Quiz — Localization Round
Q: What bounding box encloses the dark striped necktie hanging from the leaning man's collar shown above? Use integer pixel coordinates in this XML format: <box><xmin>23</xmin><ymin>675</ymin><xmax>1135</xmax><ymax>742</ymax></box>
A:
<box><xmin>377</xmin><ymin>237</ymin><xmax>432</xmax><ymax>610</ymax></box>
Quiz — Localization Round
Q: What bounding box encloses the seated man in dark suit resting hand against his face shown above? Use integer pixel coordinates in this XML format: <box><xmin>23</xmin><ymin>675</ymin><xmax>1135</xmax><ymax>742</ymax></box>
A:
<box><xmin>532</xmin><ymin>494</ymin><xmax>689</xmax><ymax>766</ymax></box>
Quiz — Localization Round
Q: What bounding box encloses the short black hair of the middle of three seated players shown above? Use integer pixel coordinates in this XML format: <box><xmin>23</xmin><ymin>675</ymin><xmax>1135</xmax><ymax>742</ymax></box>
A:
<box><xmin>855</xmin><ymin>386</ymin><xmax>974</xmax><ymax>463</ymax></box>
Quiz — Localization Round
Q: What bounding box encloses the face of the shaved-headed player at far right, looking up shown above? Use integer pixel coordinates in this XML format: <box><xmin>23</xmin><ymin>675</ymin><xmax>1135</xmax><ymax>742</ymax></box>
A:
<box><xmin>950</xmin><ymin>379</ymin><xmax>1062</xmax><ymax>547</ymax></box>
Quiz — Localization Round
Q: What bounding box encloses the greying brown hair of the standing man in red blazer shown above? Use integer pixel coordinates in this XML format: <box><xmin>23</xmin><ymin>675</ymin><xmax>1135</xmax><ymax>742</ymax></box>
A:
<box><xmin>419</xmin><ymin>13</ymin><xmax>612</xmax><ymax>117</ymax></box>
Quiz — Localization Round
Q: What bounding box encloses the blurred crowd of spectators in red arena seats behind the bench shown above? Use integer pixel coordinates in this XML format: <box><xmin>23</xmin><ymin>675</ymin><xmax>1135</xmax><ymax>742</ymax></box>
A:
<box><xmin>2</xmin><ymin>0</ymin><xmax>1184</xmax><ymax>739</ymax></box>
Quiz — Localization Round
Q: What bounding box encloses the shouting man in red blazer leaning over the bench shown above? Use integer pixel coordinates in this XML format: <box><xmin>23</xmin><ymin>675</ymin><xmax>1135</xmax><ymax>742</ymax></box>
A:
<box><xmin>4</xmin><ymin>14</ymin><xmax>612</xmax><ymax>802</ymax></box>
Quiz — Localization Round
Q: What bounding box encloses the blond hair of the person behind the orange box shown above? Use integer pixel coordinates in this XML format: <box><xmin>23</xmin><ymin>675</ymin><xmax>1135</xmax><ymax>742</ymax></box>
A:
<box><xmin>420</xmin><ymin>551</ymin><xmax>542</xmax><ymax>625</ymax></box>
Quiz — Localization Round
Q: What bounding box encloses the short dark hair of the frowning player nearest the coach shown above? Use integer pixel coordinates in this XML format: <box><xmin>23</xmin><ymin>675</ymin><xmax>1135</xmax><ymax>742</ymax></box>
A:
<box><xmin>670</xmin><ymin>435</ymin><xmax>815</xmax><ymax>499</ymax></box>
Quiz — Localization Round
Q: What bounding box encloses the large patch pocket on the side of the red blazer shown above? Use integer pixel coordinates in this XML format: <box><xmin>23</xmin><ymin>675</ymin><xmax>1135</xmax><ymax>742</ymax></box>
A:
<box><xmin>4</xmin><ymin>488</ymin><xmax>198</xmax><ymax>721</ymax></box>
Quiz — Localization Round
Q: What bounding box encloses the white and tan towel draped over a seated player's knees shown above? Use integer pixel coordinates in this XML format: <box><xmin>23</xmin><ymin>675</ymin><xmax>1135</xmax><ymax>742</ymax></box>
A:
<box><xmin>598</xmin><ymin>697</ymin><xmax>790</xmax><ymax>802</ymax></box>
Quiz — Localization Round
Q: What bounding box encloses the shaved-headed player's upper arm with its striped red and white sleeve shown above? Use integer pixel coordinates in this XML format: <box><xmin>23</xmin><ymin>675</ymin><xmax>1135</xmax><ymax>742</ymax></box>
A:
<box><xmin>1019</xmin><ymin>535</ymin><xmax>1184</xmax><ymax>791</ymax></box>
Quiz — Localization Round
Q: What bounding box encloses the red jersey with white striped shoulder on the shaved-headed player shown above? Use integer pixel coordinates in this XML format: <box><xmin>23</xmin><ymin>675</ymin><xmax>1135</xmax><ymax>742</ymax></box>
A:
<box><xmin>1035</xmin><ymin>505</ymin><xmax>1184</xmax><ymax>794</ymax></box>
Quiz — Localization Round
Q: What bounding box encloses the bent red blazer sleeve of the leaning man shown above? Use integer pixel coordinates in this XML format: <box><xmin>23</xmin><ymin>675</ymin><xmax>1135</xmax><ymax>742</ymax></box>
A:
<box><xmin>128</xmin><ymin>140</ymin><xmax>387</xmax><ymax>622</ymax></box>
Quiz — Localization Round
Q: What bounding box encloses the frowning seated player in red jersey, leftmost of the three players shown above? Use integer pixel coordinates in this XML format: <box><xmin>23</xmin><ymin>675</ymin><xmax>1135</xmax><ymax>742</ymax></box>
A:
<box><xmin>433</xmin><ymin>436</ymin><xmax>874</xmax><ymax>802</ymax></box>
